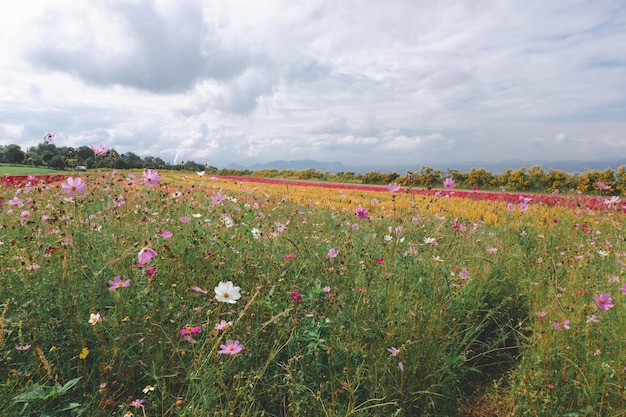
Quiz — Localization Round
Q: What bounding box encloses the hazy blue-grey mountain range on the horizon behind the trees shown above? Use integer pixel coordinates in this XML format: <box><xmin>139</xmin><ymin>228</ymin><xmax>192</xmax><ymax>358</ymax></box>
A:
<box><xmin>221</xmin><ymin>158</ymin><xmax>626</xmax><ymax>174</ymax></box>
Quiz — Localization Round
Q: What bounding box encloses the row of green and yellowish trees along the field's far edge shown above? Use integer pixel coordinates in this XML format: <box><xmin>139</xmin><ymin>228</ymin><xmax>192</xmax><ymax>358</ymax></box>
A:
<box><xmin>0</xmin><ymin>141</ymin><xmax>626</xmax><ymax>195</ymax></box>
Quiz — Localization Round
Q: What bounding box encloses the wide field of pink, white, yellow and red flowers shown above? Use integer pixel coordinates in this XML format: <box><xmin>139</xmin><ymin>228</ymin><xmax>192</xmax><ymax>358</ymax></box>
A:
<box><xmin>0</xmin><ymin>170</ymin><xmax>626</xmax><ymax>416</ymax></box>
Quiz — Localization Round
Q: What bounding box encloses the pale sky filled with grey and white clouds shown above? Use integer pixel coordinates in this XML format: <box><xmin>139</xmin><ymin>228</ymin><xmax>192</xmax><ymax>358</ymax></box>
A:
<box><xmin>0</xmin><ymin>0</ymin><xmax>626</xmax><ymax>167</ymax></box>
